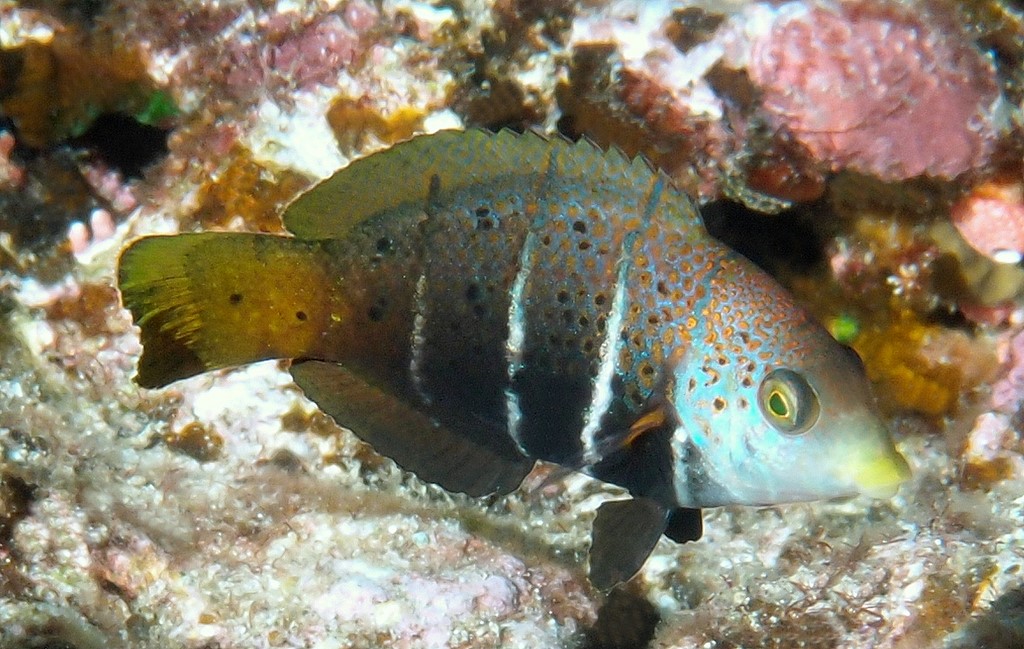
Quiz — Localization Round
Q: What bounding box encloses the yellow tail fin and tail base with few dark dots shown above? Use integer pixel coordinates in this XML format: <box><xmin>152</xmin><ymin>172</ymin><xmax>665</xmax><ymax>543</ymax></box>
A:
<box><xmin>118</xmin><ymin>232</ymin><xmax>339</xmax><ymax>388</ymax></box>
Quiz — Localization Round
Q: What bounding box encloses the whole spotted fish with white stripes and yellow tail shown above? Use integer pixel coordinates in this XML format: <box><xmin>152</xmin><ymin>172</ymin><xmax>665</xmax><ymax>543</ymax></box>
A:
<box><xmin>118</xmin><ymin>129</ymin><xmax>910</xmax><ymax>590</ymax></box>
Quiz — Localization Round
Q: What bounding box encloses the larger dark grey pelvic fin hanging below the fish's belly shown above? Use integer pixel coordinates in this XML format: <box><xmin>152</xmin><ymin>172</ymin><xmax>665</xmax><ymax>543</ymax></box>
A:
<box><xmin>590</xmin><ymin>499</ymin><xmax>668</xmax><ymax>591</ymax></box>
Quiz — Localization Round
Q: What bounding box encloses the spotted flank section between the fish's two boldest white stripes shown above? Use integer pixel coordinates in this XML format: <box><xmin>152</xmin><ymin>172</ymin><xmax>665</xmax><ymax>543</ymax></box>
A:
<box><xmin>510</xmin><ymin>171</ymin><xmax>651</xmax><ymax>465</ymax></box>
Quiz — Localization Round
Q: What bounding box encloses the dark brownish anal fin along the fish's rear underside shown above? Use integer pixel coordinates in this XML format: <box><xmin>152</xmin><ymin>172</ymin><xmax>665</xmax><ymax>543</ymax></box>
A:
<box><xmin>291</xmin><ymin>360</ymin><xmax>534</xmax><ymax>495</ymax></box>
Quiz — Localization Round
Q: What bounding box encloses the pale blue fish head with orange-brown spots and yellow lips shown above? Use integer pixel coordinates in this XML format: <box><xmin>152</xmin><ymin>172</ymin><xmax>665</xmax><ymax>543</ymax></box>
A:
<box><xmin>674</xmin><ymin>254</ymin><xmax>910</xmax><ymax>507</ymax></box>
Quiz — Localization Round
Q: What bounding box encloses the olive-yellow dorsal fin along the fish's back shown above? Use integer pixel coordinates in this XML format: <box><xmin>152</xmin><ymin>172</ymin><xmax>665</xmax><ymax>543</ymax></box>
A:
<box><xmin>284</xmin><ymin>129</ymin><xmax>695</xmax><ymax>239</ymax></box>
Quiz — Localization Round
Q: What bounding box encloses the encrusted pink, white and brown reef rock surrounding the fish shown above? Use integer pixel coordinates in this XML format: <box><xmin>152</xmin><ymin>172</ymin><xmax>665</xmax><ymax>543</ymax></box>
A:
<box><xmin>0</xmin><ymin>0</ymin><xmax>1024</xmax><ymax>649</ymax></box>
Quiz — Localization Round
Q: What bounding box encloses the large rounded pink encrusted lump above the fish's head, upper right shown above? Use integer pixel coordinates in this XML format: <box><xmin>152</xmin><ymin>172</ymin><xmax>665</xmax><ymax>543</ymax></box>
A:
<box><xmin>749</xmin><ymin>2</ymin><xmax>998</xmax><ymax>180</ymax></box>
